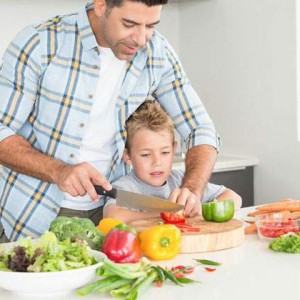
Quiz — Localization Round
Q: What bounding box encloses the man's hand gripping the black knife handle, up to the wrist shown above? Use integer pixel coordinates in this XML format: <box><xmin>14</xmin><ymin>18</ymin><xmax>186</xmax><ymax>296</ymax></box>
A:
<box><xmin>54</xmin><ymin>162</ymin><xmax>112</xmax><ymax>201</ymax></box>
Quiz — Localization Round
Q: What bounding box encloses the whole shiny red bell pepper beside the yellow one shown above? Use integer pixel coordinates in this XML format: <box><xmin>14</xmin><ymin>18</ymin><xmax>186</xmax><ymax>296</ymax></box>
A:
<box><xmin>102</xmin><ymin>228</ymin><xmax>142</xmax><ymax>263</ymax></box>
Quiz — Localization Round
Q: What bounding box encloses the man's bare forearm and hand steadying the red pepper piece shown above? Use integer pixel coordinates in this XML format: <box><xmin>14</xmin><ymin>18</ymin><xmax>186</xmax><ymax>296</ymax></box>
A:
<box><xmin>169</xmin><ymin>145</ymin><xmax>217</xmax><ymax>217</ymax></box>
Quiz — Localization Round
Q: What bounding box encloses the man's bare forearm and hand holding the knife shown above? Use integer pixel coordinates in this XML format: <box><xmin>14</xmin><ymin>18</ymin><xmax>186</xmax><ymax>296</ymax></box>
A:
<box><xmin>0</xmin><ymin>135</ymin><xmax>111</xmax><ymax>200</ymax></box>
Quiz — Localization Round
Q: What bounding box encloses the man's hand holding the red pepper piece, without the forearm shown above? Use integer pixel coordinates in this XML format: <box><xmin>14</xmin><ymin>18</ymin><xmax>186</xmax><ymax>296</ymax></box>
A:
<box><xmin>169</xmin><ymin>188</ymin><xmax>201</xmax><ymax>217</ymax></box>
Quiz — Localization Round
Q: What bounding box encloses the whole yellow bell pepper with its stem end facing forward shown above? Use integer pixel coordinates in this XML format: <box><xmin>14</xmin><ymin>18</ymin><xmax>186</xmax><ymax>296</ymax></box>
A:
<box><xmin>139</xmin><ymin>224</ymin><xmax>181</xmax><ymax>260</ymax></box>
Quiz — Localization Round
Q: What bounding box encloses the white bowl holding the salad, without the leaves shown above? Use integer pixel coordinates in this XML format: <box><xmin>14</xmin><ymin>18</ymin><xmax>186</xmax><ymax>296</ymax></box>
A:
<box><xmin>0</xmin><ymin>250</ymin><xmax>106</xmax><ymax>297</ymax></box>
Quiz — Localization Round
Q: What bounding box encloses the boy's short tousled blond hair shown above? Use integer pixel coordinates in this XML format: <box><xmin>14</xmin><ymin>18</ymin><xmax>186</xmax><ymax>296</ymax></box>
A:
<box><xmin>126</xmin><ymin>100</ymin><xmax>175</xmax><ymax>151</ymax></box>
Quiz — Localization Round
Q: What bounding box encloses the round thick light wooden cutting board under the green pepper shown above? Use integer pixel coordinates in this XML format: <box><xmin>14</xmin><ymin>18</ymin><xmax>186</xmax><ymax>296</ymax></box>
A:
<box><xmin>128</xmin><ymin>216</ymin><xmax>245</xmax><ymax>253</ymax></box>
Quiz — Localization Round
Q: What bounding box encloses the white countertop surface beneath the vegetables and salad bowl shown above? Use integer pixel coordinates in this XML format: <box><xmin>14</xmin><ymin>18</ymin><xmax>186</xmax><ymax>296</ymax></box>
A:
<box><xmin>0</xmin><ymin>207</ymin><xmax>300</xmax><ymax>300</ymax></box>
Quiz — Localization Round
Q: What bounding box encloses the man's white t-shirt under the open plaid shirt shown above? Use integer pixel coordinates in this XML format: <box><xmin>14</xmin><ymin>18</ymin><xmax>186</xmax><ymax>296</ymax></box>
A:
<box><xmin>61</xmin><ymin>47</ymin><xmax>127</xmax><ymax>210</ymax></box>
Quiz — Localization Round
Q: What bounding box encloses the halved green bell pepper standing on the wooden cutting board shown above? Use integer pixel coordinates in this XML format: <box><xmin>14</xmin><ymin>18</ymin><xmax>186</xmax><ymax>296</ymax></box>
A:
<box><xmin>202</xmin><ymin>199</ymin><xmax>234</xmax><ymax>222</ymax></box>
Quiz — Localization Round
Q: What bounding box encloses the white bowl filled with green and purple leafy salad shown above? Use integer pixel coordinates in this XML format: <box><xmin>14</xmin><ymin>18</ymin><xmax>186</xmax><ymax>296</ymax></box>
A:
<box><xmin>0</xmin><ymin>232</ymin><xmax>106</xmax><ymax>297</ymax></box>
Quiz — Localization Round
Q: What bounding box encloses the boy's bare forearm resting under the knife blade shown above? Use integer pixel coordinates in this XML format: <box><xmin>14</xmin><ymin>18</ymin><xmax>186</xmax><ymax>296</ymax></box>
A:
<box><xmin>103</xmin><ymin>204</ymin><xmax>159</xmax><ymax>223</ymax></box>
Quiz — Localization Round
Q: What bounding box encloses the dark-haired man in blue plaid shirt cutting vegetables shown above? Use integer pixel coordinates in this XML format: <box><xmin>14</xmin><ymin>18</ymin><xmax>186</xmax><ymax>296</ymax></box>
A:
<box><xmin>0</xmin><ymin>0</ymin><xmax>218</xmax><ymax>241</ymax></box>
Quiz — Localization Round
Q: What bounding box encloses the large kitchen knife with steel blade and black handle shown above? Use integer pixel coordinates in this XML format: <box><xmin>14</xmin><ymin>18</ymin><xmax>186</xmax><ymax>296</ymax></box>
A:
<box><xmin>94</xmin><ymin>185</ymin><xmax>184</xmax><ymax>212</ymax></box>
